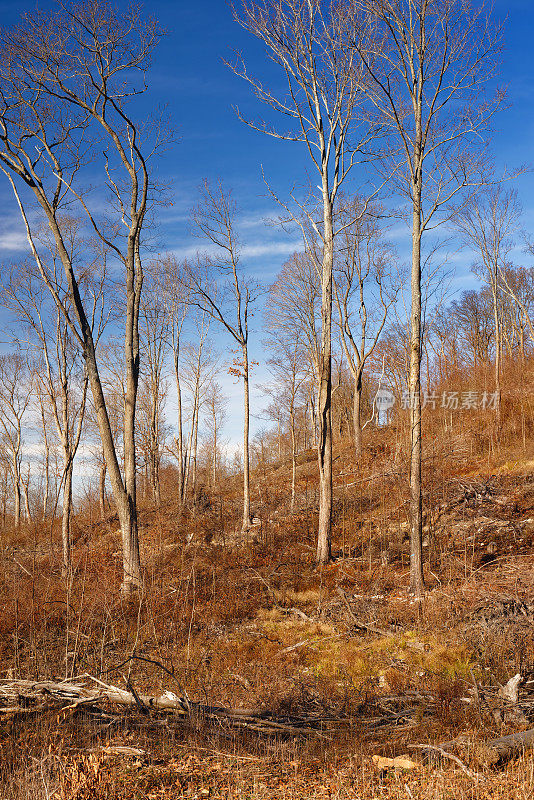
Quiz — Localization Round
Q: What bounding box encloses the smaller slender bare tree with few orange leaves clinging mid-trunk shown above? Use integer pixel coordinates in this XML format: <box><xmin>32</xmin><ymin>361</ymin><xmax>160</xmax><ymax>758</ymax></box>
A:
<box><xmin>185</xmin><ymin>181</ymin><xmax>259</xmax><ymax>531</ymax></box>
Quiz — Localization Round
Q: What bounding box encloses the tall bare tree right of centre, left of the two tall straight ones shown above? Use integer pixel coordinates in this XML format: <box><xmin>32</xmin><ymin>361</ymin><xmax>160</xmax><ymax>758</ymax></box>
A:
<box><xmin>235</xmin><ymin>0</ymin><xmax>382</xmax><ymax>564</ymax></box>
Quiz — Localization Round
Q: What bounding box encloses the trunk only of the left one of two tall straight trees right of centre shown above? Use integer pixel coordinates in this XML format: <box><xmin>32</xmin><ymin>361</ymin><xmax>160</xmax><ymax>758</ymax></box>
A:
<box><xmin>317</xmin><ymin>198</ymin><xmax>334</xmax><ymax>564</ymax></box>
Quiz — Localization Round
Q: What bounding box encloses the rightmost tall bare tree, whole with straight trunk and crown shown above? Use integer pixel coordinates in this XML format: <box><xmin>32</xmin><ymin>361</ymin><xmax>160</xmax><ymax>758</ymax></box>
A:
<box><xmin>354</xmin><ymin>0</ymin><xmax>502</xmax><ymax>596</ymax></box>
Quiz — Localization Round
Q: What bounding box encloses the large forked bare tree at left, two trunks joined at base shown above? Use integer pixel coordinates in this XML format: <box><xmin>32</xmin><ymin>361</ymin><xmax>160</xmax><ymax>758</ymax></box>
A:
<box><xmin>0</xmin><ymin>0</ymin><xmax>160</xmax><ymax>593</ymax></box>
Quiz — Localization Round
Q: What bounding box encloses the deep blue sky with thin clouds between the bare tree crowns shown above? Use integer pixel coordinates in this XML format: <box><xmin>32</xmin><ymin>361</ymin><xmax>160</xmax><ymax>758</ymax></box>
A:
<box><xmin>0</xmin><ymin>0</ymin><xmax>534</xmax><ymax>460</ymax></box>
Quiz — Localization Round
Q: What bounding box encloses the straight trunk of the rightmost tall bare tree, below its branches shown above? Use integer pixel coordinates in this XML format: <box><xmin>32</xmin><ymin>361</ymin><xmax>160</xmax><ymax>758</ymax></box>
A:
<box><xmin>408</xmin><ymin>198</ymin><xmax>425</xmax><ymax>597</ymax></box>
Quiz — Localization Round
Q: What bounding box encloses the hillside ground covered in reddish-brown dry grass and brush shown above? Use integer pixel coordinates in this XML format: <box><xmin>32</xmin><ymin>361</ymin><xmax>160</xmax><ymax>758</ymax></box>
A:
<box><xmin>0</xmin><ymin>446</ymin><xmax>534</xmax><ymax>800</ymax></box>
